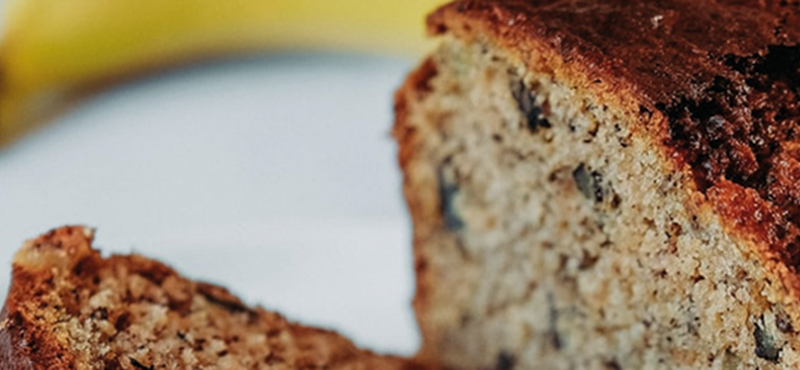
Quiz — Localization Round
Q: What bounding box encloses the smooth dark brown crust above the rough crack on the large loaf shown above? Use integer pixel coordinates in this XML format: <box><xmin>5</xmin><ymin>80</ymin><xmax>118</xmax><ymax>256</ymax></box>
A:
<box><xmin>428</xmin><ymin>0</ymin><xmax>800</xmax><ymax>108</ymax></box>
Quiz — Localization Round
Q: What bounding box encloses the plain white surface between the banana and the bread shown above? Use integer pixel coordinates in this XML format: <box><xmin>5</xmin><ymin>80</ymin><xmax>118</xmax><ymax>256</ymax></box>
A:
<box><xmin>0</xmin><ymin>55</ymin><xmax>418</xmax><ymax>354</ymax></box>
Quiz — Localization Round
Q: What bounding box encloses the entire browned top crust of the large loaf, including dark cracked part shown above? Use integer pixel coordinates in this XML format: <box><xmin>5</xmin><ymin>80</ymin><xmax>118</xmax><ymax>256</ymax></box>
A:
<box><xmin>428</xmin><ymin>0</ymin><xmax>800</xmax><ymax>290</ymax></box>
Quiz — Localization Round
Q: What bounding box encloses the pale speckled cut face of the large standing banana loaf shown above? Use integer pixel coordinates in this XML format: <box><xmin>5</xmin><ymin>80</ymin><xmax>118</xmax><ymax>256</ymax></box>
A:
<box><xmin>395</xmin><ymin>37</ymin><xmax>800</xmax><ymax>370</ymax></box>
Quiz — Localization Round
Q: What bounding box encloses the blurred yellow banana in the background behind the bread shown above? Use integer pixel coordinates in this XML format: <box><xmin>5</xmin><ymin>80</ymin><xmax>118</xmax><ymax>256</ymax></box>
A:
<box><xmin>0</xmin><ymin>0</ymin><xmax>444</xmax><ymax>147</ymax></box>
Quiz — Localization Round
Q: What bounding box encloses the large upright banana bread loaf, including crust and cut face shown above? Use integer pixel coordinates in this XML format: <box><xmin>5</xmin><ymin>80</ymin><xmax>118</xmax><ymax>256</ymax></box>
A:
<box><xmin>394</xmin><ymin>0</ymin><xmax>800</xmax><ymax>370</ymax></box>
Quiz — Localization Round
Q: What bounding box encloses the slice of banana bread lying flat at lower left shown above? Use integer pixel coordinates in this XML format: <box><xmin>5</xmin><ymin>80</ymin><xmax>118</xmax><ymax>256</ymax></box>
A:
<box><xmin>0</xmin><ymin>227</ymin><xmax>416</xmax><ymax>370</ymax></box>
